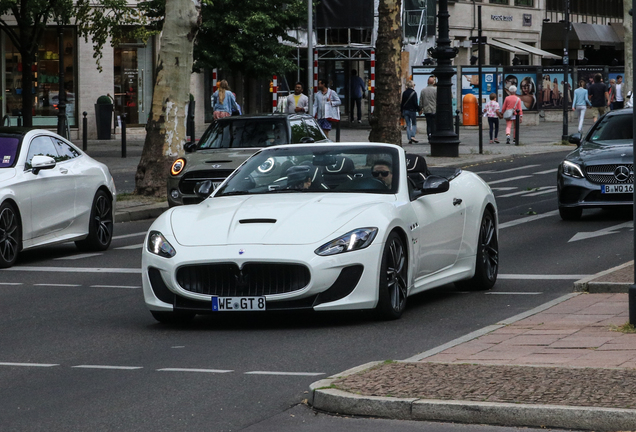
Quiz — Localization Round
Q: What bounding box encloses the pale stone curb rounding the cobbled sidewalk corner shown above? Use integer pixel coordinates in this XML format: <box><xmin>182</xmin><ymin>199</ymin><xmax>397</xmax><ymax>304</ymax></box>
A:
<box><xmin>308</xmin><ymin>361</ymin><xmax>636</xmax><ymax>431</ymax></box>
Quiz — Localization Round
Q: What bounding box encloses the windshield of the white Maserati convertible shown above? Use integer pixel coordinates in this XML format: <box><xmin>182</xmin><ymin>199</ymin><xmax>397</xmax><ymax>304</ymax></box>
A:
<box><xmin>215</xmin><ymin>146</ymin><xmax>399</xmax><ymax>197</ymax></box>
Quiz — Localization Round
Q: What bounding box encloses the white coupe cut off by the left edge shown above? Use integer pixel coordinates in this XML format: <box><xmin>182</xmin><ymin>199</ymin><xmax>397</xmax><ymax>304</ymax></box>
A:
<box><xmin>0</xmin><ymin>128</ymin><xmax>116</xmax><ymax>268</ymax></box>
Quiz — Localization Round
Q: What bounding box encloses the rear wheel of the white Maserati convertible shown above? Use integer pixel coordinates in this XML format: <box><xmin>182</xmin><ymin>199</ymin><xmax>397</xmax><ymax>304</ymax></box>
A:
<box><xmin>455</xmin><ymin>209</ymin><xmax>499</xmax><ymax>290</ymax></box>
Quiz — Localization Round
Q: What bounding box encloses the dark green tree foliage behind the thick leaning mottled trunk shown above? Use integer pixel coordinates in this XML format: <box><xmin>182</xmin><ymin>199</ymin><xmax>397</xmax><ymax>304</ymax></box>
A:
<box><xmin>140</xmin><ymin>0</ymin><xmax>307</xmax><ymax>77</ymax></box>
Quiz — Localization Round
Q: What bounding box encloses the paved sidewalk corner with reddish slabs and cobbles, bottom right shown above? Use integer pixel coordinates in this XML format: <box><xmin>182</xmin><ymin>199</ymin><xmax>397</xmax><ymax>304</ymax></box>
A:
<box><xmin>311</xmin><ymin>261</ymin><xmax>636</xmax><ymax>431</ymax></box>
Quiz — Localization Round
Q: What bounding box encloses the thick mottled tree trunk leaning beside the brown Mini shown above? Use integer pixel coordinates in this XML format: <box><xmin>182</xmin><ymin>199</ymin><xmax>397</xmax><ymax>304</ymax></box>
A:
<box><xmin>135</xmin><ymin>0</ymin><xmax>201</xmax><ymax>197</ymax></box>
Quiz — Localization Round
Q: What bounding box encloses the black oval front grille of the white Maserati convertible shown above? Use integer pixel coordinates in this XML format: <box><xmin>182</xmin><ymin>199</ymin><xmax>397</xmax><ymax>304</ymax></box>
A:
<box><xmin>177</xmin><ymin>263</ymin><xmax>311</xmax><ymax>297</ymax></box>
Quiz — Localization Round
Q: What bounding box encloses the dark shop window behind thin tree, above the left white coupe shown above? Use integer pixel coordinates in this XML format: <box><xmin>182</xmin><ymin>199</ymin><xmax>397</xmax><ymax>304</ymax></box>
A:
<box><xmin>4</xmin><ymin>28</ymin><xmax>77</xmax><ymax>126</ymax></box>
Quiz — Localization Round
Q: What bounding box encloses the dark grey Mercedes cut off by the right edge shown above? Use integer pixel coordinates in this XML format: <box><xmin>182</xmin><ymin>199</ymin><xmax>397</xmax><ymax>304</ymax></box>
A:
<box><xmin>557</xmin><ymin>108</ymin><xmax>634</xmax><ymax>220</ymax></box>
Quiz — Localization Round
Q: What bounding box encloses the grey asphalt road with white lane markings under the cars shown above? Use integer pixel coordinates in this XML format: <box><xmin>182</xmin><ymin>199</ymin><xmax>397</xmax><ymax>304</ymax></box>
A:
<box><xmin>0</xmin><ymin>152</ymin><xmax>632</xmax><ymax>432</ymax></box>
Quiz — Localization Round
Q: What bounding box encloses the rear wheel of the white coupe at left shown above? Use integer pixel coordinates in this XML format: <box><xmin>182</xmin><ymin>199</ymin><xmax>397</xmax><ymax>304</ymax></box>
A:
<box><xmin>75</xmin><ymin>190</ymin><xmax>113</xmax><ymax>251</ymax></box>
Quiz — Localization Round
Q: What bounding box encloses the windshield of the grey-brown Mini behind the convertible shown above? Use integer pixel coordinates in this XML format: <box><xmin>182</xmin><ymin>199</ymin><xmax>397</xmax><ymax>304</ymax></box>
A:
<box><xmin>197</xmin><ymin>119</ymin><xmax>289</xmax><ymax>149</ymax></box>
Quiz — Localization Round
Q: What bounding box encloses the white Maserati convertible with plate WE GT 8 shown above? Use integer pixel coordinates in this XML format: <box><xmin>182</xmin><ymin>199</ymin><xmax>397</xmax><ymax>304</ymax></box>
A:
<box><xmin>142</xmin><ymin>143</ymin><xmax>499</xmax><ymax>323</ymax></box>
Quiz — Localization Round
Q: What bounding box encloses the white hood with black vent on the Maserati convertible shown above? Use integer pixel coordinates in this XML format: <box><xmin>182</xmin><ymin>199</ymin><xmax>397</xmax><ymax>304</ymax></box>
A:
<box><xmin>170</xmin><ymin>193</ymin><xmax>395</xmax><ymax>246</ymax></box>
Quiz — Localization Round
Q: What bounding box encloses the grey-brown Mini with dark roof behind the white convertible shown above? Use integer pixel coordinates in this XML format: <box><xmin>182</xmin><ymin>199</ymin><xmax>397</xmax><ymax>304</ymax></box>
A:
<box><xmin>167</xmin><ymin>114</ymin><xmax>330</xmax><ymax>207</ymax></box>
